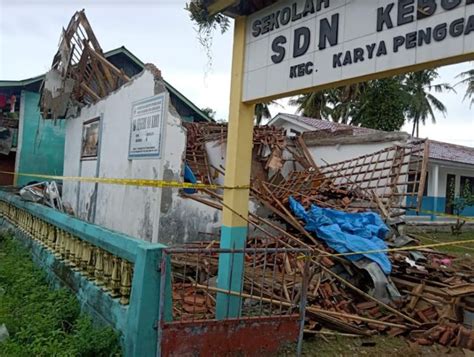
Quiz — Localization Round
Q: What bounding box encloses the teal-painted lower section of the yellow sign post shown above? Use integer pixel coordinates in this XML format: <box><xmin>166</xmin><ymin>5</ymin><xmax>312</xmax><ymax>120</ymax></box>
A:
<box><xmin>216</xmin><ymin>226</ymin><xmax>247</xmax><ymax>320</ymax></box>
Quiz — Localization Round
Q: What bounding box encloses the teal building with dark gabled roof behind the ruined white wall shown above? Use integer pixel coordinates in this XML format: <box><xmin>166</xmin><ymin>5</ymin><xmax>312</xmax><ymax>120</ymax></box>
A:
<box><xmin>0</xmin><ymin>47</ymin><xmax>165</xmax><ymax>186</ymax></box>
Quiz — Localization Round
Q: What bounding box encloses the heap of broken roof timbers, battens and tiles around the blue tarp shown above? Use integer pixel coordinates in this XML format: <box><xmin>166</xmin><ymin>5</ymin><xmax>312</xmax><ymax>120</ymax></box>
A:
<box><xmin>173</xmin><ymin>124</ymin><xmax>474</xmax><ymax>349</ymax></box>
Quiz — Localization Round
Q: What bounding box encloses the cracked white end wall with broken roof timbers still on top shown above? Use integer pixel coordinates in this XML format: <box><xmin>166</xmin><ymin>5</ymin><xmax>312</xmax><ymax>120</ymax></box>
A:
<box><xmin>34</xmin><ymin>11</ymin><xmax>219</xmax><ymax>243</ymax></box>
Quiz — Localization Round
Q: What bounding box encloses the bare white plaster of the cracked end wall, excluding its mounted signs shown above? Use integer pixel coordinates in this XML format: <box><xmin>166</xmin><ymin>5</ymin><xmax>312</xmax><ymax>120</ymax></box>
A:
<box><xmin>63</xmin><ymin>70</ymin><xmax>220</xmax><ymax>243</ymax></box>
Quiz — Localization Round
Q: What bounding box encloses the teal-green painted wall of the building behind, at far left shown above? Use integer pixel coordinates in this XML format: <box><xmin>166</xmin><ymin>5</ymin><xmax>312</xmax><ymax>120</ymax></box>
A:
<box><xmin>16</xmin><ymin>91</ymin><xmax>66</xmax><ymax>185</ymax></box>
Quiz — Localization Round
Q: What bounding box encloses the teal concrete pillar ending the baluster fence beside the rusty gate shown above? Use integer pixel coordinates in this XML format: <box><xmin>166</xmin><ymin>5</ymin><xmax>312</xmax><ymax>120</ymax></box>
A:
<box><xmin>125</xmin><ymin>245</ymin><xmax>172</xmax><ymax>357</ymax></box>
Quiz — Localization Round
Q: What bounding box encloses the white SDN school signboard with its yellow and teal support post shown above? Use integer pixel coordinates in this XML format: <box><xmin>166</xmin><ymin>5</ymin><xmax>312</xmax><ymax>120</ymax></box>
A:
<box><xmin>215</xmin><ymin>0</ymin><xmax>474</xmax><ymax>319</ymax></box>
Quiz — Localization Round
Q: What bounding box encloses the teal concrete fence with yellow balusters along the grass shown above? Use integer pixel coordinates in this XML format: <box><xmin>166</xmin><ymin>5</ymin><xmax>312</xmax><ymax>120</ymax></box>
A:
<box><xmin>0</xmin><ymin>191</ymin><xmax>171</xmax><ymax>356</ymax></box>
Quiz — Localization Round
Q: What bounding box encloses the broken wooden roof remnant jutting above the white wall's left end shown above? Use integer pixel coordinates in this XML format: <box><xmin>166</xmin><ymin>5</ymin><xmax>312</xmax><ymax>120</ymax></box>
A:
<box><xmin>40</xmin><ymin>10</ymin><xmax>130</xmax><ymax>119</ymax></box>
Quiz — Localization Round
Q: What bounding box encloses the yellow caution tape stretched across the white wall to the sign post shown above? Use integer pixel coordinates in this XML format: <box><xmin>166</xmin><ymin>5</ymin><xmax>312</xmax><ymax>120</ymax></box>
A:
<box><xmin>0</xmin><ymin>171</ymin><xmax>250</xmax><ymax>190</ymax></box>
